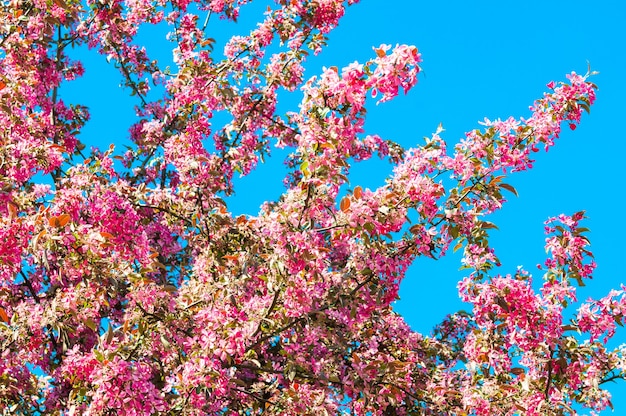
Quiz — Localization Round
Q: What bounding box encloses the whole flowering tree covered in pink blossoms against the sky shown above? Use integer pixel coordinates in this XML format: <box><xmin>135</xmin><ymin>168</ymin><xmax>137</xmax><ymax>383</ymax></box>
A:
<box><xmin>0</xmin><ymin>0</ymin><xmax>626</xmax><ymax>415</ymax></box>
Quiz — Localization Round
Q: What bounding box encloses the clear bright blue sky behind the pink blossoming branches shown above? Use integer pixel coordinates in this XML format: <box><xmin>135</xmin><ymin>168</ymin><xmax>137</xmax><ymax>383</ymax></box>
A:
<box><xmin>65</xmin><ymin>0</ymin><xmax>626</xmax><ymax>412</ymax></box>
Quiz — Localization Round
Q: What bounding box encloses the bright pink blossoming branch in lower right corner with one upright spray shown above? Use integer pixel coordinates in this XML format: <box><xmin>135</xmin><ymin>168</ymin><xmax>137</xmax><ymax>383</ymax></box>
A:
<box><xmin>459</xmin><ymin>212</ymin><xmax>625</xmax><ymax>414</ymax></box>
